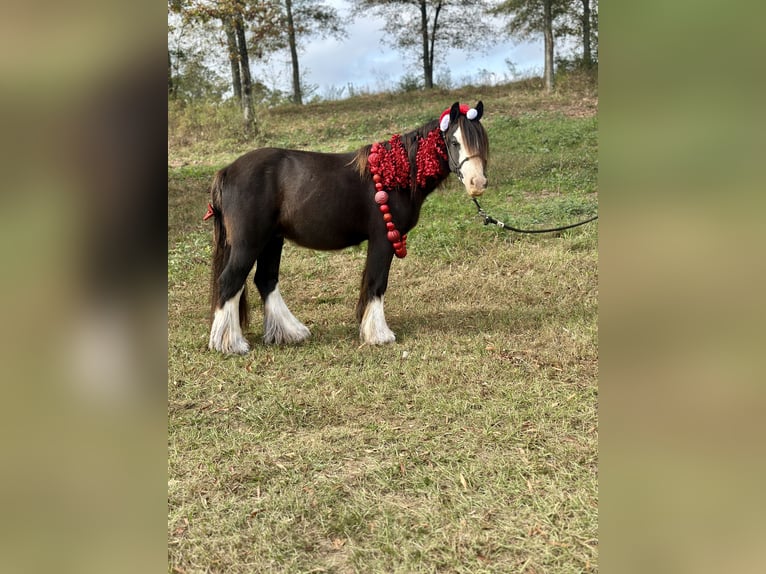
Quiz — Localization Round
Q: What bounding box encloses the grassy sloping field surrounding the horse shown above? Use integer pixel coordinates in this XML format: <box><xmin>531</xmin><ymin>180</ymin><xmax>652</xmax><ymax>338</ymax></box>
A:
<box><xmin>168</xmin><ymin>79</ymin><xmax>598</xmax><ymax>573</ymax></box>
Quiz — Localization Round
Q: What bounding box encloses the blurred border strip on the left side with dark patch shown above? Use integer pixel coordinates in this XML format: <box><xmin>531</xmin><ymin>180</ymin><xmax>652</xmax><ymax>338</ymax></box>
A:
<box><xmin>0</xmin><ymin>1</ymin><xmax>167</xmax><ymax>573</ymax></box>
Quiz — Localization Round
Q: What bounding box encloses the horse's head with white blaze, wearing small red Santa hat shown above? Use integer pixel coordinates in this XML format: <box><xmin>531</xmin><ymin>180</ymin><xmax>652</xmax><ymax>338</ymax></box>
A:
<box><xmin>439</xmin><ymin>102</ymin><xmax>489</xmax><ymax>197</ymax></box>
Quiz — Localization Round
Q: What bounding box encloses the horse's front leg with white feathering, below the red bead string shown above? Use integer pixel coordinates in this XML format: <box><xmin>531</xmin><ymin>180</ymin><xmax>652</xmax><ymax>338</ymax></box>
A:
<box><xmin>356</xmin><ymin>239</ymin><xmax>396</xmax><ymax>345</ymax></box>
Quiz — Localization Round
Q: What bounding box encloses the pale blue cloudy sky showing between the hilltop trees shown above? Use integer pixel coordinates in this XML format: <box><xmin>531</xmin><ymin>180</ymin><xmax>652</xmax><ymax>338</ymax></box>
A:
<box><xmin>252</xmin><ymin>0</ymin><xmax>544</xmax><ymax>98</ymax></box>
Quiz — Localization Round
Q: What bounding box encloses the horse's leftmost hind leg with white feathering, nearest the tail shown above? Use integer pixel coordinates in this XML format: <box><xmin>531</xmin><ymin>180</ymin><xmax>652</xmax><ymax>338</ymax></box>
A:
<box><xmin>208</xmin><ymin>244</ymin><xmax>257</xmax><ymax>354</ymax></box>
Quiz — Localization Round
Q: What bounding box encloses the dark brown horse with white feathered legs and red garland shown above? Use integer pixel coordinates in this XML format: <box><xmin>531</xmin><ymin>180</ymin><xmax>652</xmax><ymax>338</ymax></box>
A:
<box><xmin>205</xmin><ymin>102</ymin><xmax>489</xmax><ymax>353</ymax></box>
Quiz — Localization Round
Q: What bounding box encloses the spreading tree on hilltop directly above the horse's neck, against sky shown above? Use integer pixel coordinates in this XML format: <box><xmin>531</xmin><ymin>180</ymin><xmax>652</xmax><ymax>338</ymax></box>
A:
<box><xmin>354</xmin><ymin>0</ymin><xmax>493</xmax><ymax>89</ymax></box>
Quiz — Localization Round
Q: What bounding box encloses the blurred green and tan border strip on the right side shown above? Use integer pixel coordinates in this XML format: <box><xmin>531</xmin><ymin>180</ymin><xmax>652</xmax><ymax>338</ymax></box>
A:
<box><xmin>599</xmin><ymin>0</ymin><xmax>766</xmax><ymax>574</ymax></box>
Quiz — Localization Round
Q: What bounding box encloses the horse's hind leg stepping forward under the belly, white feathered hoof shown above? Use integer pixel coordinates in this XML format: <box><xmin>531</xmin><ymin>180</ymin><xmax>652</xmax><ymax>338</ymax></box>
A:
<box><xmin>255</xmin><ymin>236</ymin><xmax>311</xmax><ymax>345</ymax></box>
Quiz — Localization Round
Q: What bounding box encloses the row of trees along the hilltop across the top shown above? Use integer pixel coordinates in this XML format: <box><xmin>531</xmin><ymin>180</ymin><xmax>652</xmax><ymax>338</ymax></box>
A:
<box><xmin>168</xmin><ymin>0</ymin><xmax>598</xmax><ymax>130</ymax></box>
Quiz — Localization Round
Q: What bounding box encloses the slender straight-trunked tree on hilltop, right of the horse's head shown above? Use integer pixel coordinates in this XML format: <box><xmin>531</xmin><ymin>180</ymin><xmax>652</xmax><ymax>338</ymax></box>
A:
<box><xmin>491</xmin><ymin>0</ymin><xmax>570</xmax><ymax>92</ymax></box>
